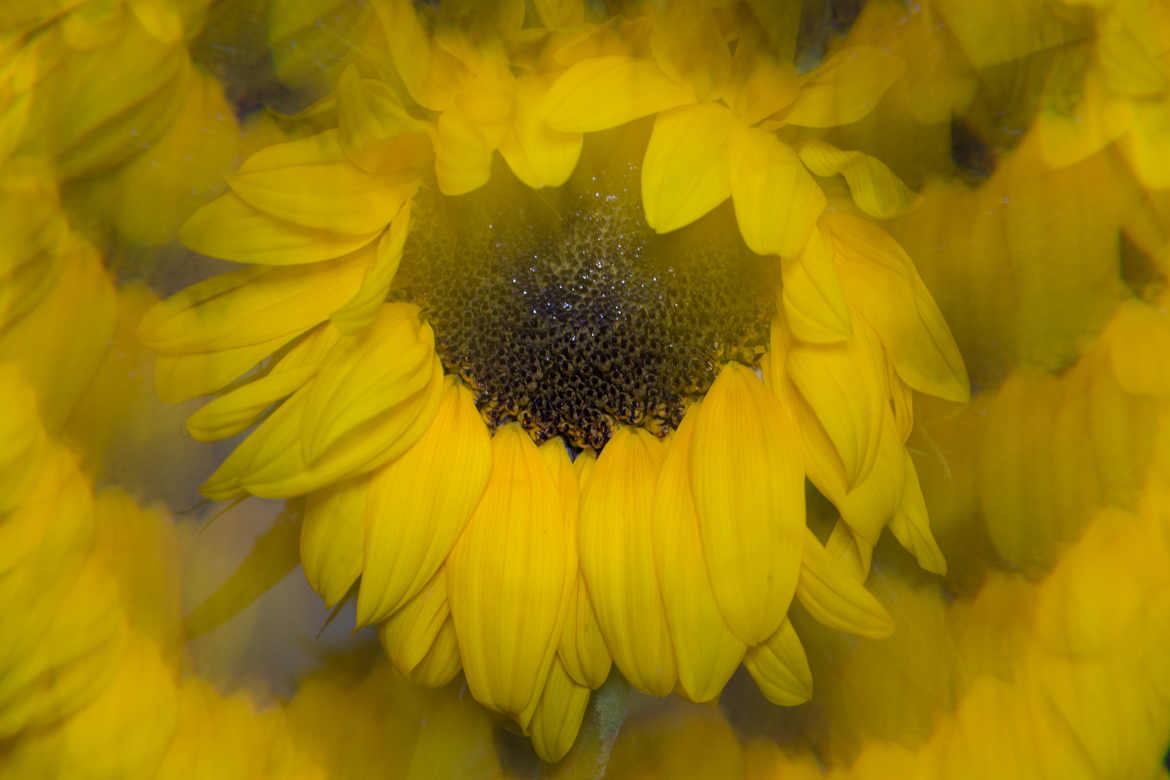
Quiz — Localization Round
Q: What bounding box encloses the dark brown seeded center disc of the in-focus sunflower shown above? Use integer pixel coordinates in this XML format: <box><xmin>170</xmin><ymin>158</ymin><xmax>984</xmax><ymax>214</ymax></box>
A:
<box><xmin>395</xmin><ymin>130</ymin><xmax>779</xmax><ymax>449</ymax></box>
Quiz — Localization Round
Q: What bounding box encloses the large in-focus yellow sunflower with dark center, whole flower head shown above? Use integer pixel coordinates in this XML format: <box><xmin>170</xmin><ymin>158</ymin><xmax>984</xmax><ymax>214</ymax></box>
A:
<box><xmin>140</xmin><ymin>0</ymin><xmax>968</xmax><ymax>760</ymax></box>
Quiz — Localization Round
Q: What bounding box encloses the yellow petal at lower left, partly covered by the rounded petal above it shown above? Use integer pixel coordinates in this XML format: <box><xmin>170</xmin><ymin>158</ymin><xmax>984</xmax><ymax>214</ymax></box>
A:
<box><xmin>200</xmin><ymin>358</ymin><xmax>443</xmax><ymax>501</ymax></box>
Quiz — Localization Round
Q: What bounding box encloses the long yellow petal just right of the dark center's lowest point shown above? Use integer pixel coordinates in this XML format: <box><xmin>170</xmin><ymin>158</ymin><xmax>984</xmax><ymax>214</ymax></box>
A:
<box><xmin>579</xmin><ymin>428</ymin><xmax>675</xmax><ymax>696</ymax></box>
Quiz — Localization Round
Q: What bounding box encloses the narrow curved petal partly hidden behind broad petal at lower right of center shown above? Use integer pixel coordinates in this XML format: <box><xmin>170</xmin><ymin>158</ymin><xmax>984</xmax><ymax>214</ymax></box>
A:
<box><xmin>653</xmin><ymin>406</ymin><xmax>746</xmax><ymax>702</ymax></box>
